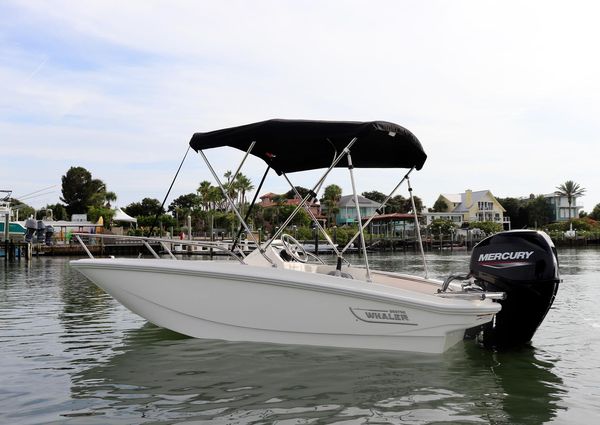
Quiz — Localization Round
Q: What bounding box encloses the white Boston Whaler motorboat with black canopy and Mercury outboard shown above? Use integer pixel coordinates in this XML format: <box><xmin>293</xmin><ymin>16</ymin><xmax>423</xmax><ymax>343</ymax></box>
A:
<box><xmin>71</xmin><ymin>119</ymin><xmax>560</xmax><ymax>353</ymax></box>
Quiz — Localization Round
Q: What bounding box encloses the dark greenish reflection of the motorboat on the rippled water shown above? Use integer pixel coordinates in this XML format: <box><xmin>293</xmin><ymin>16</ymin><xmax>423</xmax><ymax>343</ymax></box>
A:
<box><xmin>64</xmin><ymin>324</ymin><xmax>564</xmax><ymax>424</ymax></box>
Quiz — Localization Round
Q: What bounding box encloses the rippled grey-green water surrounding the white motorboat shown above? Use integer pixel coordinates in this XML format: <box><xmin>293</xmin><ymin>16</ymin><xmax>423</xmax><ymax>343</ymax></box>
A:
<box><xmin>0</xmin><ymin>249</ymin><xmax>600</xmax><ymax>425</ymax></box>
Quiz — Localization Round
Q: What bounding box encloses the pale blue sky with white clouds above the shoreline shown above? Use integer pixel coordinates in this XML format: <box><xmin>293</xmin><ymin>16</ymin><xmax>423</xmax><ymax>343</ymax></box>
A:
<box><xmin>0</xmin><ymin>0</ymin><xmax>600</xmax><ymax>212</ymax></box>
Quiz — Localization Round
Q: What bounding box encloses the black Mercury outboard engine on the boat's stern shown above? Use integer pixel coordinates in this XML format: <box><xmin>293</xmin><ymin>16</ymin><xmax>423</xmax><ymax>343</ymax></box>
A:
<box><xmin>470</xmin><ymin>230</ymin><xmax>560</xmax><ymax>349</ymax></box>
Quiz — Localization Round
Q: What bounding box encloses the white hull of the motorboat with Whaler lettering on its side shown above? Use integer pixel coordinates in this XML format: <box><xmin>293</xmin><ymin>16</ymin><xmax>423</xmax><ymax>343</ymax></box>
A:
<box><xmin>71</xmin><ymin>259</ymin><xmax>500</xmax><ymax>353</ymax></box>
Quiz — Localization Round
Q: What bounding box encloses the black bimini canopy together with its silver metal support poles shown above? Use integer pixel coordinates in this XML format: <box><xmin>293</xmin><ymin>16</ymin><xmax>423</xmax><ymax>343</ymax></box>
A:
<box><xmin>190</xmin><ymin>119</ymin><xmax>427</xmax><ymax>280</ymax></box>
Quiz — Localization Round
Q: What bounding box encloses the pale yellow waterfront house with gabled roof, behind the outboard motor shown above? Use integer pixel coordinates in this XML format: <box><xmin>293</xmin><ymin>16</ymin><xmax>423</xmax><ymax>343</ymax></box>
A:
<box><xmin>424</xmin><ymin>190</ymin><xmax>510</xmax><ymax>230</ymax></box>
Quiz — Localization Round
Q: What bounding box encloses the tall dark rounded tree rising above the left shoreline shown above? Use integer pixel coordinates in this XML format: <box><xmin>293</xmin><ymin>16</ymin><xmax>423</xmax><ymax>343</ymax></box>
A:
<box><xmin>60</xmin><ymin>167</ymin><xmax>106</xmax><ymax>215</ymax></box>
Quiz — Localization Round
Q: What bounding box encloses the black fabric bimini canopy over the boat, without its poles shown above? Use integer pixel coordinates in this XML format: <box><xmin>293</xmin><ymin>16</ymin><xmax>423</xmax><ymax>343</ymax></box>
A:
<box><xmin>190</xmin><ymin>119</ymin><xmax>427</xmax><ymax>175</ymax></box>
